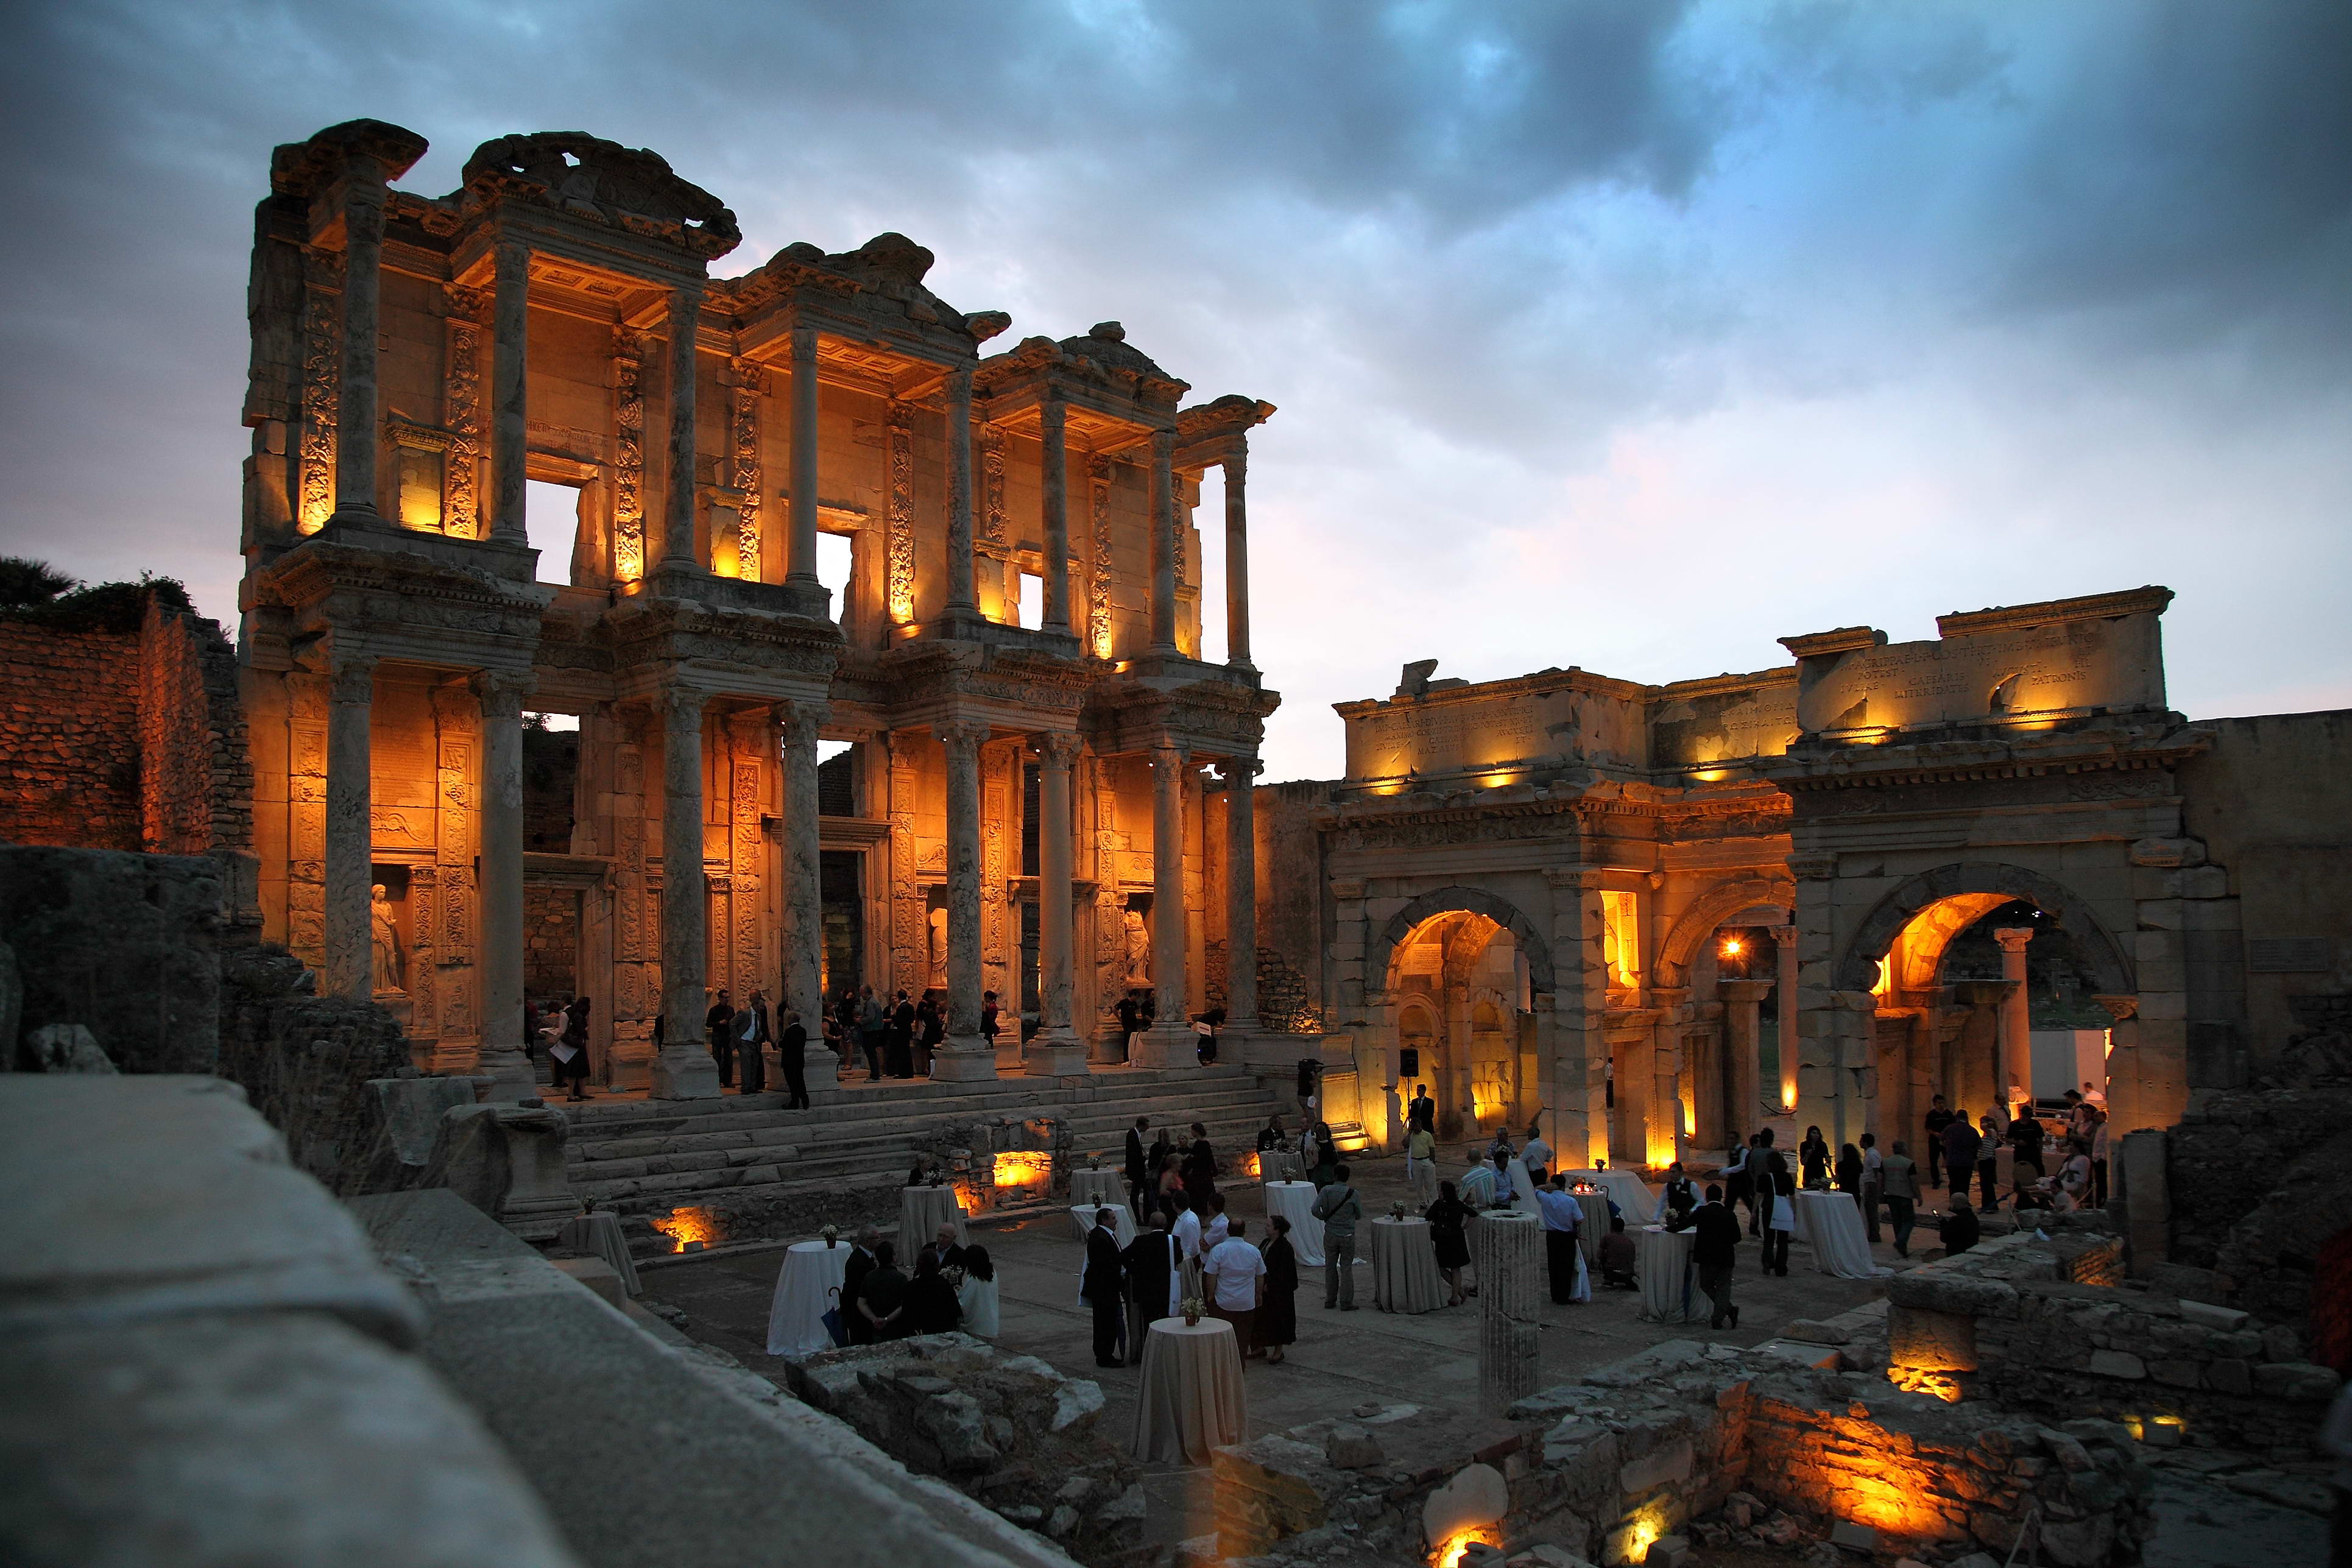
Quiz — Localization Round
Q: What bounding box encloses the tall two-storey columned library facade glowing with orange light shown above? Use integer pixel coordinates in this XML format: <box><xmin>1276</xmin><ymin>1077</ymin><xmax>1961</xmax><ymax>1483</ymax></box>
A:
<box><xmin>240</xmin><ymin>120</ymin><xmax>1277</xmax><ymax>1098</ymax></box>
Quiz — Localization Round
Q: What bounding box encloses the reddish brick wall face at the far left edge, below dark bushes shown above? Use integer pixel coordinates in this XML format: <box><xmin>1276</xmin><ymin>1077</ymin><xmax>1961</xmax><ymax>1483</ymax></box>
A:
<box><xmin>0</xmin><ymin>618</ymin><xmax>141</xmax><ymax>849</ymax></box>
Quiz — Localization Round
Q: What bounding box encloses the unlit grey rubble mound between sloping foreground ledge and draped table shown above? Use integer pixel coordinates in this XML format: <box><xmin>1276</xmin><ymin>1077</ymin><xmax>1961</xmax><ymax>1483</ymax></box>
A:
<box><xmin>786</xmin><ymin>1335</ymin><xmax>1143</xmax><ymax>1563</ymax></box>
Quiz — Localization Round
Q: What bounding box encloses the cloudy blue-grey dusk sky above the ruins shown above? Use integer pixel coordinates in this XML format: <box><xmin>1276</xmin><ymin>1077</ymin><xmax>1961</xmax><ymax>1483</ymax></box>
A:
<box><xmin>0</xmin><ymin>0</ymin><xmax>2352</xmax><ymax>778</ymax></box>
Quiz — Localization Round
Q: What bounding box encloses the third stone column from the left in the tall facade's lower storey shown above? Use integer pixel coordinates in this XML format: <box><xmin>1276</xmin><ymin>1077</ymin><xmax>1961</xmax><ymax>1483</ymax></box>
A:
<box><xmin>649</xmin><ymin>687</ymin><xmax>719</xmax><ymax>1100</ymax></box>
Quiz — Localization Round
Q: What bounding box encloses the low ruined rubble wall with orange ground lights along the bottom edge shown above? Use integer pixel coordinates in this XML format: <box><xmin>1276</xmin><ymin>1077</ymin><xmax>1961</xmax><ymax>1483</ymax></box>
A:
<box><xmin>1216</xmin><ymin>1340</ymin><xmax>2152</xmax><ymax>1568</ymax></box>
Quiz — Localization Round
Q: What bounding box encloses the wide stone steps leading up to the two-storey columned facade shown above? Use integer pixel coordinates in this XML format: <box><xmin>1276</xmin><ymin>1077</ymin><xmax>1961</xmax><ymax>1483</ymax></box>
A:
<box><xmin>550</xmin><ymin>1062</ymin><xmax>1296</xmax><ymax>1251</ymax></box>
